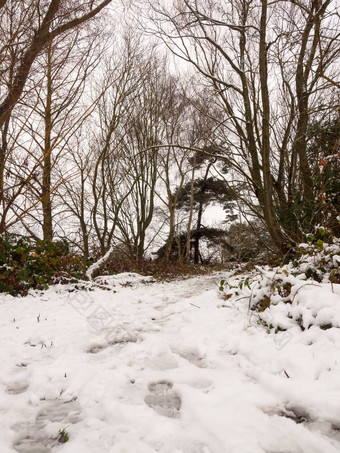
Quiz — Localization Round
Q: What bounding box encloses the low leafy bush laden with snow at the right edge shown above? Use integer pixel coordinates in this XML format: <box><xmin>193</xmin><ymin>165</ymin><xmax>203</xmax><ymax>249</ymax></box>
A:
<box><xmin>220</xmin><ymin>235</ymin><xmax>340</xmax><ymax>333</ymax></box>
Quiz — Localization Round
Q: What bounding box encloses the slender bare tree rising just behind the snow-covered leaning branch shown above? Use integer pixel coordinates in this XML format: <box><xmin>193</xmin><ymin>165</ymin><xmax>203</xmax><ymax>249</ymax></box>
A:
<box><xmin>90</xmin><ymin>36</ymin><xmax>143</xmax><ymax>255</ymax></box>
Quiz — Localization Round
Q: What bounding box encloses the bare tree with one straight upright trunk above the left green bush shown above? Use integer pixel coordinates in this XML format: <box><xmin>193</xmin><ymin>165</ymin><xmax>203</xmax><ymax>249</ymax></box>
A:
<box><xmin>17</xmin><ymin>26</ymin><xmax>101</xmax><ymax>240</ymax></box>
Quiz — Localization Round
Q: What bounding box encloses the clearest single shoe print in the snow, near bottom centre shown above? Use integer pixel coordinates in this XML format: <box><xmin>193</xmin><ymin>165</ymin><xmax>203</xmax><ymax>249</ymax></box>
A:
<box><xmin>144</xmin><ymin>381</ymin><xmax>182</xmax><ymax>418</ymax></box>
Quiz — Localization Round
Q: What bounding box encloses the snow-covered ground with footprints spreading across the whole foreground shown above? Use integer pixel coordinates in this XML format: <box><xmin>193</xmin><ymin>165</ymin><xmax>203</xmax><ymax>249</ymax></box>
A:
<box><xmin>0</xmin><ymin>274</ymin><xmax>340</xmax><ymax>453</ymax></box>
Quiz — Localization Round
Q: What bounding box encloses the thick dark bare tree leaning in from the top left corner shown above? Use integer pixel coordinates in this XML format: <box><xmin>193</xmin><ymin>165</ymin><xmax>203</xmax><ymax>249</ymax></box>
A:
<box><xmin>0</xmin><ymin>0</ymin><xmax>112</xmax><ymax>230</ymax></box>
